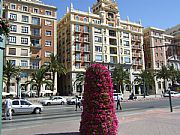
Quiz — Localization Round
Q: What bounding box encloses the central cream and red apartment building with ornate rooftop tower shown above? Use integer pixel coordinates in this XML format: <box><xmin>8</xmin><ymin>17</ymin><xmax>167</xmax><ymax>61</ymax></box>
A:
<box><xmin>57</xmin><ymin>0</ymin><xmax>144</xmax><ymax>95</ymax></box>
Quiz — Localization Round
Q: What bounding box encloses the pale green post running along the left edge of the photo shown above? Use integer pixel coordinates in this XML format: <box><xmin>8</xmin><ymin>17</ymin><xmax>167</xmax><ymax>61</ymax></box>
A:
<box><xmin>0</xmin><ymin>0</ymin><xmax>5</xmax><ymax>135</ymax></box>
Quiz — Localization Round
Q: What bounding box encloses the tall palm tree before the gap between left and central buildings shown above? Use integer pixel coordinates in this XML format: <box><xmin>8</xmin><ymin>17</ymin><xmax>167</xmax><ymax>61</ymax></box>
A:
<box><xmin>47</xmin><ymin>53</ymin><xmax>67</xmax><ymax>91</ymax></box>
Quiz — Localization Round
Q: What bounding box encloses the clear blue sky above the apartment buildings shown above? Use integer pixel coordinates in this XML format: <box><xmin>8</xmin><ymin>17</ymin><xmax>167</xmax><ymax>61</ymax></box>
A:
<box><xmin>42</xmin><ymin>0</ymin><xmax>180</xmax><ymax>29</ymax></box>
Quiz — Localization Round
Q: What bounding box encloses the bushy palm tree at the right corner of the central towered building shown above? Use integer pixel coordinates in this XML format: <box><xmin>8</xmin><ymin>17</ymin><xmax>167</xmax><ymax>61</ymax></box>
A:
<box><xmin>134</xmin><ymin>70</ymin><xmax>155</xmax><ymax>98</ymax></box>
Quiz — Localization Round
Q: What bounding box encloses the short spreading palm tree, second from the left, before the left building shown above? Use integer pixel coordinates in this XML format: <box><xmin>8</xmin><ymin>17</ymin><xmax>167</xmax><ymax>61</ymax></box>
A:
<box><xmin>26</xmin><ymin>66</ymin><xmax>52</xmax><ymax>97</ymax></box>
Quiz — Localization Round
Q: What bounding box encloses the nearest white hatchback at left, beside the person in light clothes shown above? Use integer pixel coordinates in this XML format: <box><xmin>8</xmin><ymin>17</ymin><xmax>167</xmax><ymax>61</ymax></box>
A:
<box><xmin>12</xmin><ymin>99</ymin><xmax>43</xmax><ymax>114</ymax></box>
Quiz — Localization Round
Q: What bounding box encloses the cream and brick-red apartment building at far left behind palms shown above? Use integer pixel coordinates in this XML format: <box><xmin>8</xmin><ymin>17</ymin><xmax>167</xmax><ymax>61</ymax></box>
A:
<box><xmin>4</xmin><ymin>0</ymin><xmax>57</xmax><ymax>96</ymax></box>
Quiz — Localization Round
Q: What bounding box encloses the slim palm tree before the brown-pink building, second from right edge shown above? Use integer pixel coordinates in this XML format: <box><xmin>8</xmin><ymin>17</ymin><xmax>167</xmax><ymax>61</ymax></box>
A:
<box><xmin>156</xmin><ymin>66</ymin><xmax>170</xmax><ymax>92</ymax></box>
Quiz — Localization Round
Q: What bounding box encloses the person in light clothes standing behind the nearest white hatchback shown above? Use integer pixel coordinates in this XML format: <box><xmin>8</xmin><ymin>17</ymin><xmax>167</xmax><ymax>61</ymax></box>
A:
<box><xmin>4</xmin><ymin>97</ymin><xmax>12</xmax><ymax>120</ymax></box>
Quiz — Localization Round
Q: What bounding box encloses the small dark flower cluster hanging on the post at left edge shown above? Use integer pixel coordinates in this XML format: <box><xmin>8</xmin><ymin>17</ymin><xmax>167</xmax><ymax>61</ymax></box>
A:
<box><xmin>0</xmin><ymin>18</ymin><xmax>10</xmax><ymax>36</ymax></box>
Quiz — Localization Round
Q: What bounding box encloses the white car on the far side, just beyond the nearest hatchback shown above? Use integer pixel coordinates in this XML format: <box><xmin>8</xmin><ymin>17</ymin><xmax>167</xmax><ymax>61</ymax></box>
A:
<box><xmin>41</xmin><ymin>96</ymin><xmax>67</xmax><ymax>105</ymax></box>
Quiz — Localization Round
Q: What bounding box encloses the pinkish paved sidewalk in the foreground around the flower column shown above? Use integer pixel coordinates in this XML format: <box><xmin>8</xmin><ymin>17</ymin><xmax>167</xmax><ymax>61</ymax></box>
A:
<box><xmin>2</xmin><ymin>108</ymin><xmax>180</xmax><ymax>135</ymax></box>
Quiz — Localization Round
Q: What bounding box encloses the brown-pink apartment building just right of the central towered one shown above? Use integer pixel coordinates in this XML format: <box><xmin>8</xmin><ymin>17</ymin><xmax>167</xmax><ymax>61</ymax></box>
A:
<box><xmin>143</xmin><ymin>27</ymin><xmax>173</xmax><ymax>94</ymax></box>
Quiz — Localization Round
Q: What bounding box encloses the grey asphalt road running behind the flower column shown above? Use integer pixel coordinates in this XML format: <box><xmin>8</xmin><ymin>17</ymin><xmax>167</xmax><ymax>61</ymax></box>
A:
<box><xmin>2</xmin><ymin>98</ymin><xmax>180</xmax><ymax>133</ymax></box>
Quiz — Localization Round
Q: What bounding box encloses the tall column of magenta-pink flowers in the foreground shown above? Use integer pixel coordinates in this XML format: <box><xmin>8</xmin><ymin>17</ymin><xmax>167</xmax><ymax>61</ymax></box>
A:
<box><xmin>80</xmin><ymin>64</ymin><xmax>118</xmax><ymax>135</ymax></box>
